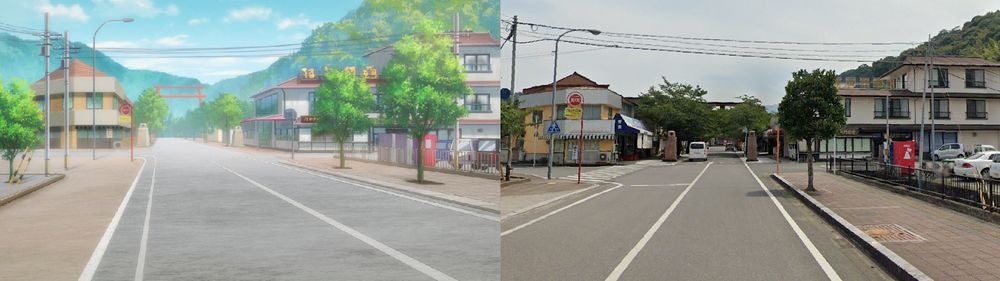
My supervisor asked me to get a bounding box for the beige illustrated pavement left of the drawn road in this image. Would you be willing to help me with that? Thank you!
[0,155,142,280]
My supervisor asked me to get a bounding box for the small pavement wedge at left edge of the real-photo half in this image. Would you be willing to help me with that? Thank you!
[500,177,597,218]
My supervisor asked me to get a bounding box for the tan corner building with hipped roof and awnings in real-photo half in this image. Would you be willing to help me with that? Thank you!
[516,72,653,164]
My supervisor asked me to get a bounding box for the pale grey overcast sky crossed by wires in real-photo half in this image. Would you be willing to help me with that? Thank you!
[500,0,1000,105]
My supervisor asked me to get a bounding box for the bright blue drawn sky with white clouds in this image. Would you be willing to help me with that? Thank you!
[0,0,361,83]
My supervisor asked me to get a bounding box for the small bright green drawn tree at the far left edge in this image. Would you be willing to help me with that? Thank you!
[0,80,44,180]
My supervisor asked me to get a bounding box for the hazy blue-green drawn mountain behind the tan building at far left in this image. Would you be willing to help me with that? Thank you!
[0,33,201,113]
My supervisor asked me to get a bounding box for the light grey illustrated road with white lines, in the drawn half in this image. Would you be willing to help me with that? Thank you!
[83,139,500,280]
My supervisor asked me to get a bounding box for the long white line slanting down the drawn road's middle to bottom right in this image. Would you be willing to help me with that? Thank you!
[222,167,457,281]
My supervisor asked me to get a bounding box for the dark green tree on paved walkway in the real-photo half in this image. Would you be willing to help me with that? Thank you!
[778,69,847,191]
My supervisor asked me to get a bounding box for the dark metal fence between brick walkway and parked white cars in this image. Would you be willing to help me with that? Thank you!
[827,159,1000,212]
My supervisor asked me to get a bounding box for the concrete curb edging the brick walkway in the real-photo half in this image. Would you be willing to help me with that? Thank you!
[771,174,934,280]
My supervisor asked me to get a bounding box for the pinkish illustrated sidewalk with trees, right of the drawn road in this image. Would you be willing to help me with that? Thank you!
[283,155,500,213]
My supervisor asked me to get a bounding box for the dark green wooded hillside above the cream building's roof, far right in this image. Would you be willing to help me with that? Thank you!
[840,10,1000,77]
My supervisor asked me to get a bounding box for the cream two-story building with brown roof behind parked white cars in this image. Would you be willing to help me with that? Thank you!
[800,57,1000,158]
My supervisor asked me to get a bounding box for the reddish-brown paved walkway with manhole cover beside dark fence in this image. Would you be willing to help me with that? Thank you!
[782,171,1000,280]
